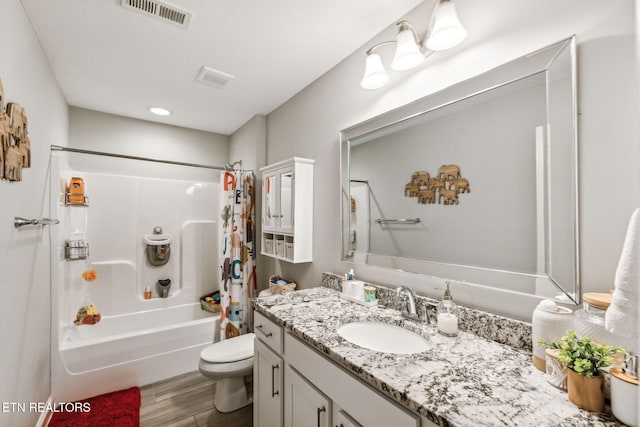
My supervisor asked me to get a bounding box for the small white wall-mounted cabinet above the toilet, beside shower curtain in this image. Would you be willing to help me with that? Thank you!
[260,157,315,263]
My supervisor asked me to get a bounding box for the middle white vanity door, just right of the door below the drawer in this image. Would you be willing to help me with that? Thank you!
[284,365,331,427]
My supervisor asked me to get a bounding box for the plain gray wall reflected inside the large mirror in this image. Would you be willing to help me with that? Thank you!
[350,81,545,274]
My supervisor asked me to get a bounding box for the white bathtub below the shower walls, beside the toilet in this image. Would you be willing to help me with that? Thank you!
[52,303,219,402]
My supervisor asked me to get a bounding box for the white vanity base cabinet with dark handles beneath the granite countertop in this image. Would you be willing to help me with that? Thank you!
[253,311,436,427]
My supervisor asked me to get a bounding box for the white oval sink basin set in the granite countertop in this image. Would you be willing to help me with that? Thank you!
[338,322,431,354]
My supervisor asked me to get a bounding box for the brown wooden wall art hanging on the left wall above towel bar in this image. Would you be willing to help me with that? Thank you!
[0,81,31,181]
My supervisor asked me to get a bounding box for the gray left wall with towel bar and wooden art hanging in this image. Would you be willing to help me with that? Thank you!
[0,0,68,427]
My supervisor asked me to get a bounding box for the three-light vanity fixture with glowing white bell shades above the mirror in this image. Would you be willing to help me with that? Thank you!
[360,0,467,89]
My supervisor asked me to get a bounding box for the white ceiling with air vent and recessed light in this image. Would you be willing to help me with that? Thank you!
[21,0,421,135]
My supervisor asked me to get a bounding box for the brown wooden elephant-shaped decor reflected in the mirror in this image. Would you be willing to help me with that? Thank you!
[404,165,471,205]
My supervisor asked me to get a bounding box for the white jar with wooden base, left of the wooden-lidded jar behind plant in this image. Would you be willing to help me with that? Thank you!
[531,300,573,372]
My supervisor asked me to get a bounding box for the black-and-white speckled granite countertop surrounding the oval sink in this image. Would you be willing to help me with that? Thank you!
[252,287,621,427]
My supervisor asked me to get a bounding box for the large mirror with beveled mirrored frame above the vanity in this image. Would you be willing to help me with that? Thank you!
[340,37,580,303]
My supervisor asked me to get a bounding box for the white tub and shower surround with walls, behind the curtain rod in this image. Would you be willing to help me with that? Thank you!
[51,153,219,402]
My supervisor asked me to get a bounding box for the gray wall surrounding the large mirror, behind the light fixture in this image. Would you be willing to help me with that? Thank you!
[267,0,640,320]
